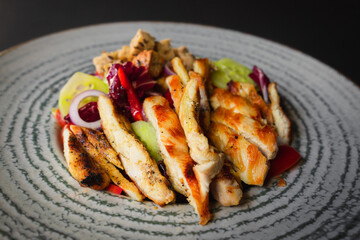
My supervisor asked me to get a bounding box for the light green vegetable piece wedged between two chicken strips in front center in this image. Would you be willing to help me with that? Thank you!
[131,121,163,163]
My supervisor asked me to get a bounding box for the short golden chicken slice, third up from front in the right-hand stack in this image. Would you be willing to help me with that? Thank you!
[210,88,261,120]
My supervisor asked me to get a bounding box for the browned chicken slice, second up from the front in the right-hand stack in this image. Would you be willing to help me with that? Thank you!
[211,107,278,159]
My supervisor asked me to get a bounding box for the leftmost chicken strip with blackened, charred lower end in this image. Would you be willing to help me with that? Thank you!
[62,126,110,190]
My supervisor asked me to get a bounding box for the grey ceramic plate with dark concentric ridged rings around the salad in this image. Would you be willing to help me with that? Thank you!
[0,22,360,239]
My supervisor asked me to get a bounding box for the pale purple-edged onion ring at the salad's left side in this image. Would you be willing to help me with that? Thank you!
[69,90,105,129]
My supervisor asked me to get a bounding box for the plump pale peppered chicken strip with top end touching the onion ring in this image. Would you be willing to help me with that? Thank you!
[98,96,175,206]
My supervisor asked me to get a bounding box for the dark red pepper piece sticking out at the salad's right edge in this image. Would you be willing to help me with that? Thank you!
[267,145,301,179]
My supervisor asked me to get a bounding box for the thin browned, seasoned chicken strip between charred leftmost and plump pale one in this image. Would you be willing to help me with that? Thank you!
[70,125,144,201]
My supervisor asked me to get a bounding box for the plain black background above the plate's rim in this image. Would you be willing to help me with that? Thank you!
[0,0,360,84]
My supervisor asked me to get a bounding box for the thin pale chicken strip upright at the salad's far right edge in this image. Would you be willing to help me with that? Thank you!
[268,82,291,144]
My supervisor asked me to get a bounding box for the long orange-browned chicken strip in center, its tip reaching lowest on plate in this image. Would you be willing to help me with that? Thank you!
[143,96,211,225]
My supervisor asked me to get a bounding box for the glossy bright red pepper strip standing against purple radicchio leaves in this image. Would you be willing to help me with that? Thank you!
[118,67,144,121]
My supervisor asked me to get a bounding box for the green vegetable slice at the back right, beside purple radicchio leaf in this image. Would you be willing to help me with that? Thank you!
[211,58,255,89]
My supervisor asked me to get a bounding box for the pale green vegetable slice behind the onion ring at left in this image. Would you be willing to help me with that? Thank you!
[58,72,109,117]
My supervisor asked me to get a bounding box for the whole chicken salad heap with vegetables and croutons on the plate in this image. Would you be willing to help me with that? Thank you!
[52,30,300,225]
